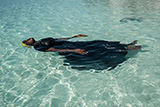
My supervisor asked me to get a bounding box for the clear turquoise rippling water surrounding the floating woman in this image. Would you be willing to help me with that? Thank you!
[0,0,160,107]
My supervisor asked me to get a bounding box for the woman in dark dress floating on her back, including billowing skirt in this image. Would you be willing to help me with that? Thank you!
[22,34,141,69]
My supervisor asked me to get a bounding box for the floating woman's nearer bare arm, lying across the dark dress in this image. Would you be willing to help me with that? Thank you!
[46,48,88,55]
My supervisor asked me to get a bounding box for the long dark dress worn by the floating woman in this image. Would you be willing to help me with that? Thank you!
[34,38,127,70]
